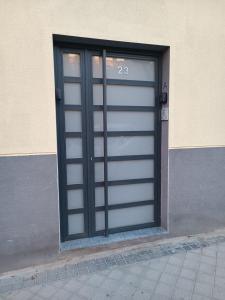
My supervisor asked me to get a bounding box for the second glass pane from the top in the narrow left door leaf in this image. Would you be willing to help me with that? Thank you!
[64,83,81,105]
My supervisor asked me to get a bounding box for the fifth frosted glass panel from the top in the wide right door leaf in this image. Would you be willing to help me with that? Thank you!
[95,159,154,182]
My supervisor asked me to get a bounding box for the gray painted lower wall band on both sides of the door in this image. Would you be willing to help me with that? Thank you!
[0,148,225,272]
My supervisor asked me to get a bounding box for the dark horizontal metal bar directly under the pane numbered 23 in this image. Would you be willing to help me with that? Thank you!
[92,78,156,87]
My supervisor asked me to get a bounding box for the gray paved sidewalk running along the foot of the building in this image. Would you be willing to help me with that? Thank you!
[0,231,225,300]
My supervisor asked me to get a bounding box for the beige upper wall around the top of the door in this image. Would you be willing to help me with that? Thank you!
[0,0,225,155]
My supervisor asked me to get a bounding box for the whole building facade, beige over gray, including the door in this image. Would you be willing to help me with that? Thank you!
[0,0,225,271]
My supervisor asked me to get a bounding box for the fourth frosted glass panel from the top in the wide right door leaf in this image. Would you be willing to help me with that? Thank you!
[94,136,154,157]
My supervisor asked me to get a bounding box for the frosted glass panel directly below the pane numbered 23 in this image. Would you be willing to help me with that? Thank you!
[93,84,155,106]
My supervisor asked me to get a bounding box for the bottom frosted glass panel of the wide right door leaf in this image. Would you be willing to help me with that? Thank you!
[96,205,154,231]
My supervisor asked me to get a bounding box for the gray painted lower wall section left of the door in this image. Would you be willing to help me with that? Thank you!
[0,155,59,270]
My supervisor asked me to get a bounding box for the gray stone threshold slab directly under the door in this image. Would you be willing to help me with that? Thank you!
[60,227,168,251]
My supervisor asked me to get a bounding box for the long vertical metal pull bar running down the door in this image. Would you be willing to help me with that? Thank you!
[102,49,109,236]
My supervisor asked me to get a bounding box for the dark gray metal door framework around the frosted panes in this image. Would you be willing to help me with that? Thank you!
[54,39,161,241]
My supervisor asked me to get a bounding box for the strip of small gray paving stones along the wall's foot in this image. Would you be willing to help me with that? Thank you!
[0,229,225,293]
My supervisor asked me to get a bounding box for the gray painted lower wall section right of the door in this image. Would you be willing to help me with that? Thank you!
[169,148,225,235]
